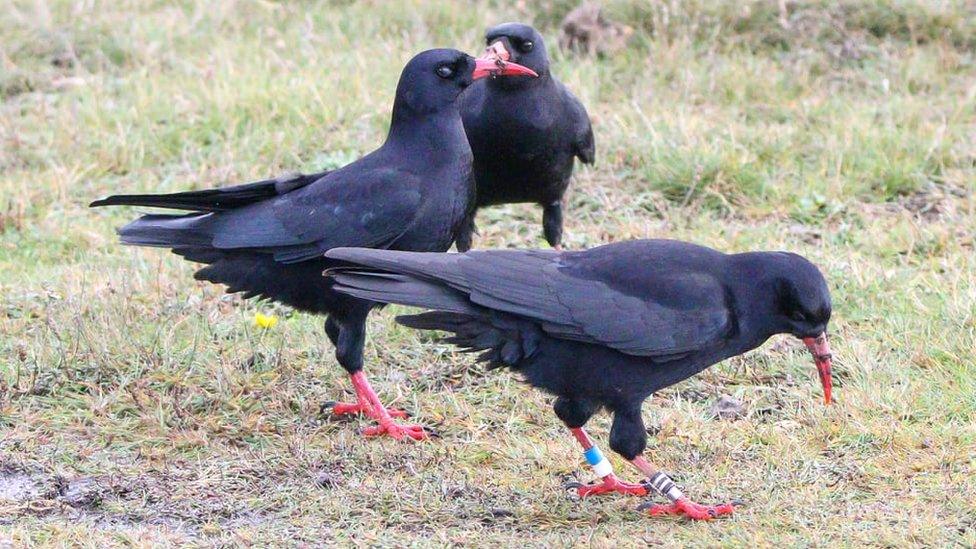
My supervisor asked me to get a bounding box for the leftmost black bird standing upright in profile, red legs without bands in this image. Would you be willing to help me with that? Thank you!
[92,49,534,439]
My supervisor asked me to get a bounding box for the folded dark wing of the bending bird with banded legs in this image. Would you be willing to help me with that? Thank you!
[327,245,732,360]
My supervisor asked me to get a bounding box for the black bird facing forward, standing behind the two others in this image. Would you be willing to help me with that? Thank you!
[458,23,595,251]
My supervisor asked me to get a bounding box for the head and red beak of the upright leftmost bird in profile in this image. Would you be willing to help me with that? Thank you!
[396,49,538,113]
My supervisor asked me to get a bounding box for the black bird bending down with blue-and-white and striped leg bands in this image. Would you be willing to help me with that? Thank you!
[326,240,831,519]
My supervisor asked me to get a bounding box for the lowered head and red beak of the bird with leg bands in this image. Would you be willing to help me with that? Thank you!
[770,252,832,404]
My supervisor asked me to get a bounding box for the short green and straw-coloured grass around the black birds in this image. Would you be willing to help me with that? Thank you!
[0,0,976,547]
